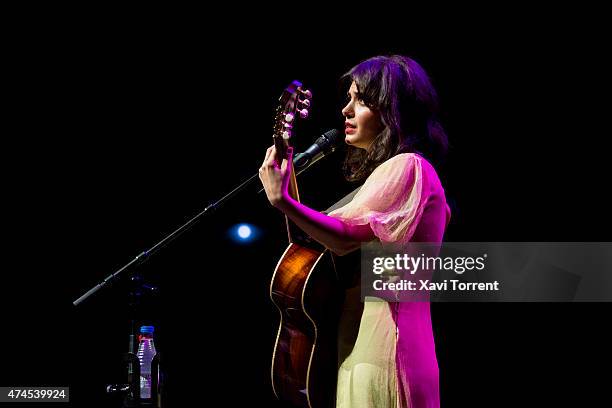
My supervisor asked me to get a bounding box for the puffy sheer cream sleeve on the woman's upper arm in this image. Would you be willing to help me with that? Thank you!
[328,153,426,243]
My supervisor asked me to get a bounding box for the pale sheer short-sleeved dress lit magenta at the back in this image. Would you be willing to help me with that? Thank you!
[328,153,450,408]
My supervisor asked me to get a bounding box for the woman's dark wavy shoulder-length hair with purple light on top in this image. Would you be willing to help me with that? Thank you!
[342,55,448,181]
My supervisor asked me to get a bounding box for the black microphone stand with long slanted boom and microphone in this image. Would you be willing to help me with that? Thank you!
[72,147,336,407]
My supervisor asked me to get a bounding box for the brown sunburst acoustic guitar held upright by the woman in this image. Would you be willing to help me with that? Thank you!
[270,81,343,408]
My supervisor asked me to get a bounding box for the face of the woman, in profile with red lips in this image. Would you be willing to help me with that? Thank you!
[342,82,384,149]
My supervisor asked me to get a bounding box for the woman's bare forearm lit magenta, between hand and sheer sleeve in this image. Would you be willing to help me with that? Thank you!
[276,197,374,255]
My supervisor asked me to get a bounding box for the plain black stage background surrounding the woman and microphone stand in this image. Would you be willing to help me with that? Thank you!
[0,10,612,407]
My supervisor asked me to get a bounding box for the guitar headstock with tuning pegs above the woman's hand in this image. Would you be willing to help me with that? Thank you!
[272,81,312,165]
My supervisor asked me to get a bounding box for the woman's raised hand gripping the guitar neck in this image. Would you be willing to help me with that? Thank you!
[259,146,293,208]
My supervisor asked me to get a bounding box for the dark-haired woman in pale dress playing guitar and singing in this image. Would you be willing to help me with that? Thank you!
[260,55,450,408]
